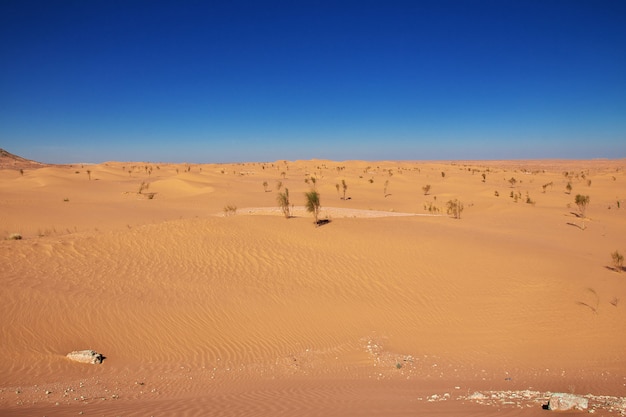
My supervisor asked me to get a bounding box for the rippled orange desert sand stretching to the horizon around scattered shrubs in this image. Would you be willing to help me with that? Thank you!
[0,154,626,416]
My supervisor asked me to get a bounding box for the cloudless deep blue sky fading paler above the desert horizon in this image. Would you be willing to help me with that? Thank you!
[0,0,626,163]
